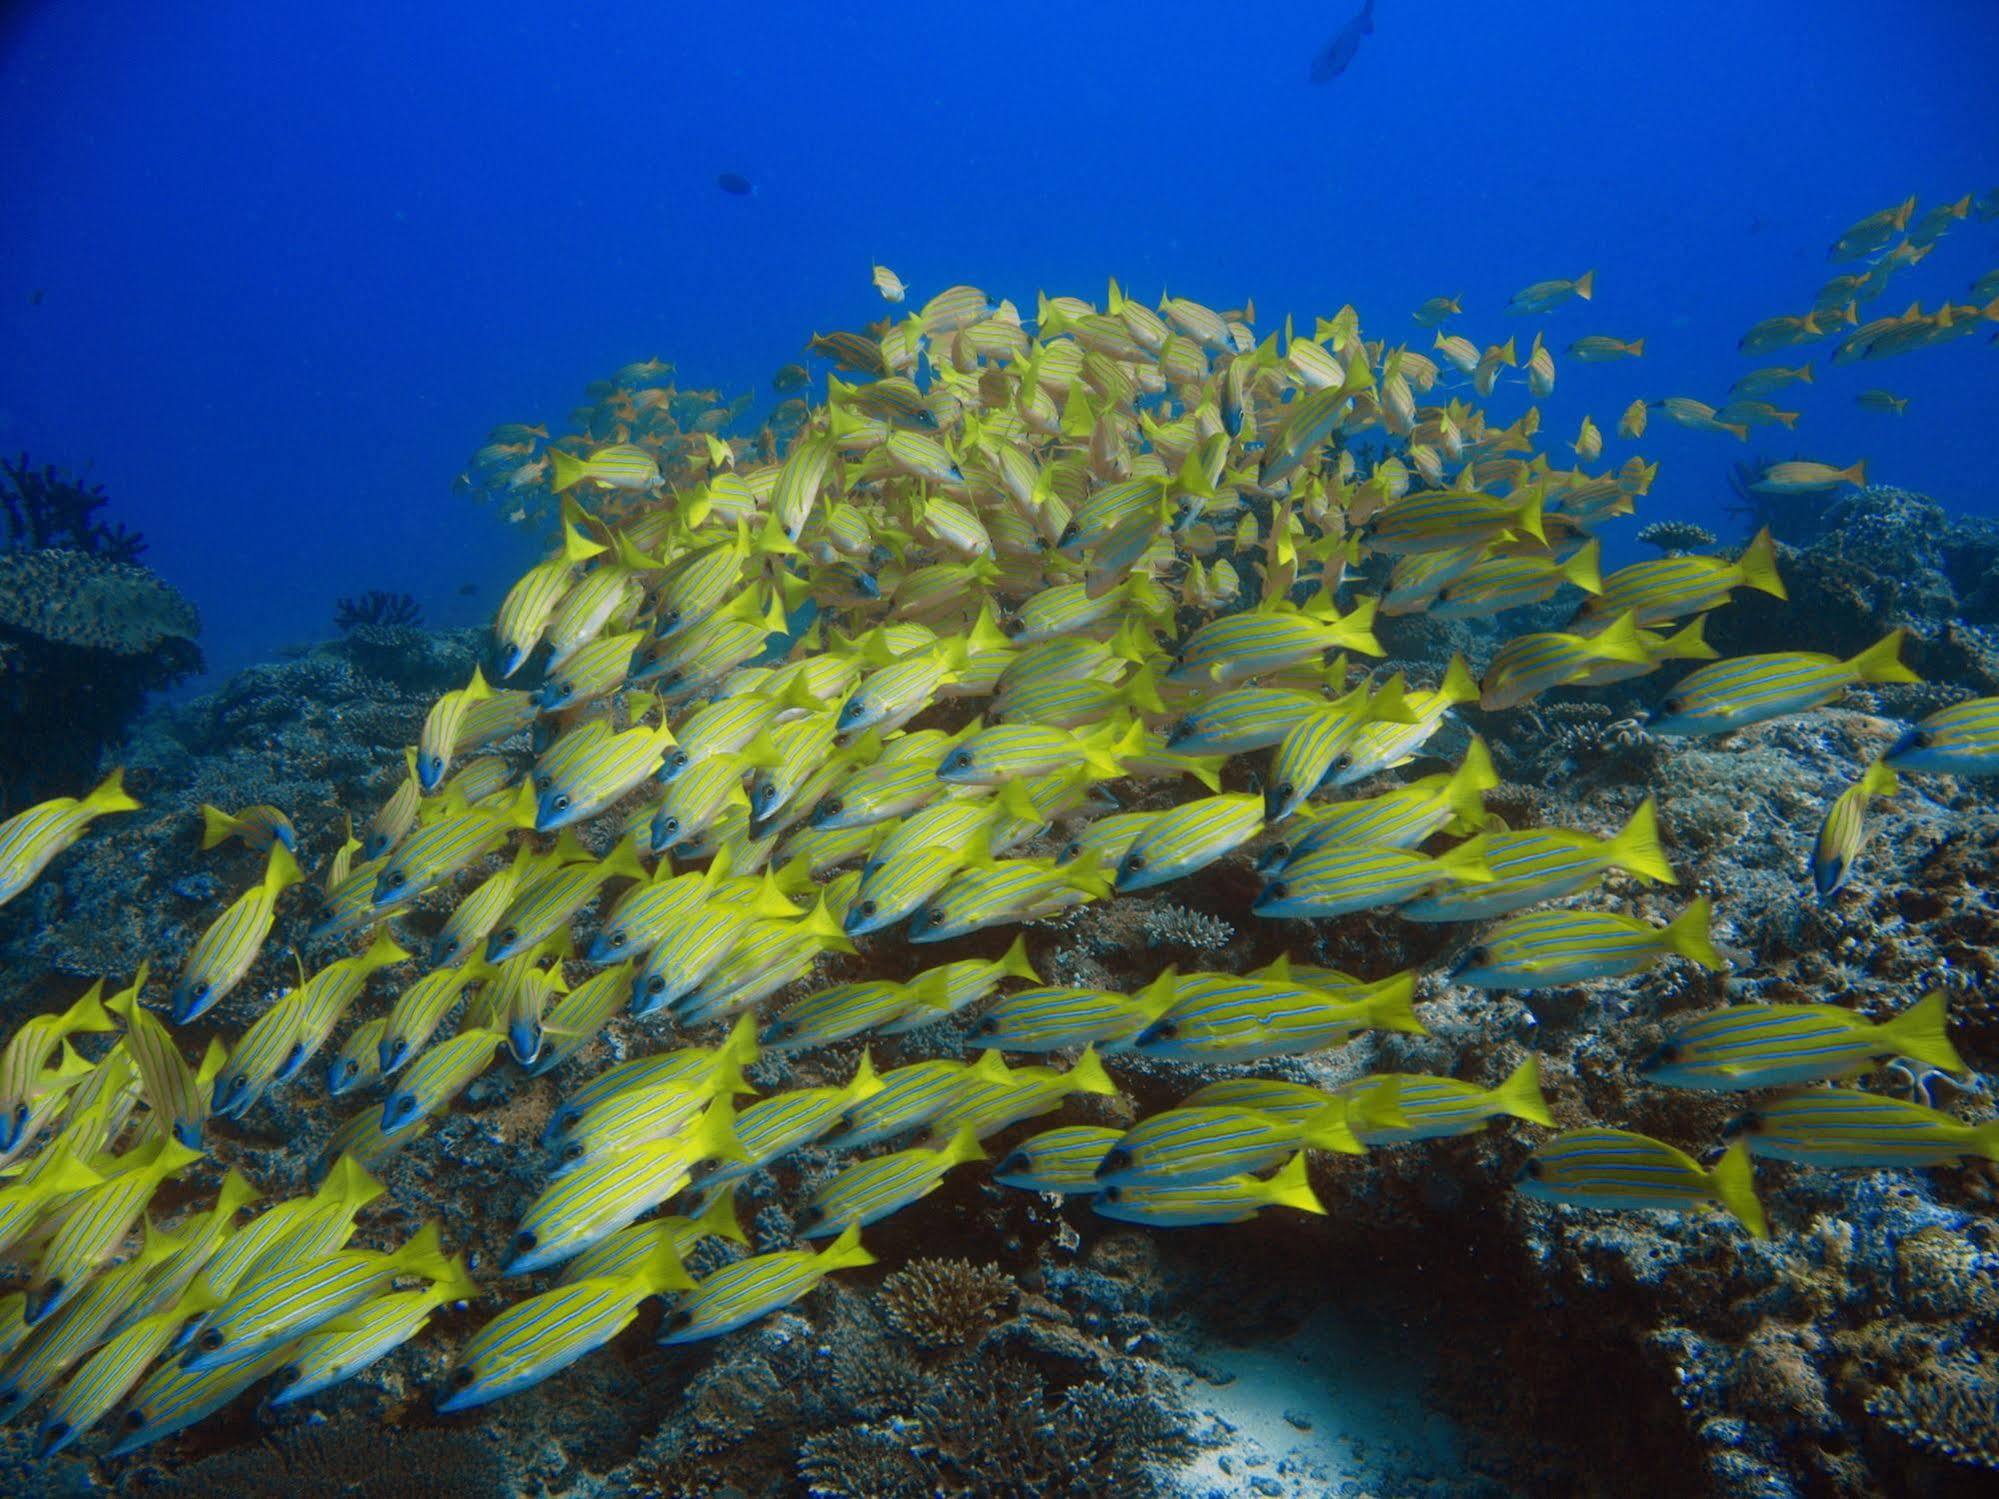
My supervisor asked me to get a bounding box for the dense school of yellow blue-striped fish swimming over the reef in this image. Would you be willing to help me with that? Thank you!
[0,184,1999,1455]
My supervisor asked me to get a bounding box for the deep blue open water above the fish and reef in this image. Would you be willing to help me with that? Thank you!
[0,0,1999,670]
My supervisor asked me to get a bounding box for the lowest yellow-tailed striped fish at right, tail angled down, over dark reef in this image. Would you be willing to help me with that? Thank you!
[1513,1129,1769,1239]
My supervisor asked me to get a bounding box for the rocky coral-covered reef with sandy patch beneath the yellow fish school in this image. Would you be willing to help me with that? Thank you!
[0,490,1999,1499]
